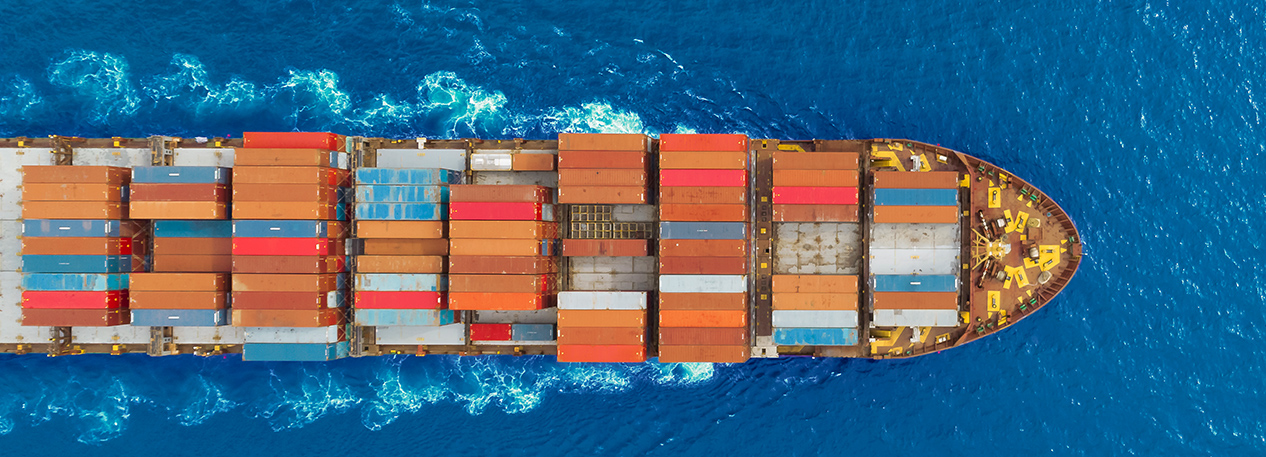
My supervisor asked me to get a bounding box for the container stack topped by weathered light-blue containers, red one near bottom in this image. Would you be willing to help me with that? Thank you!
[353,168,461,327]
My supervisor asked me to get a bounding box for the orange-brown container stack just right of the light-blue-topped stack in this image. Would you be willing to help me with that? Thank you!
[448,185,558,311]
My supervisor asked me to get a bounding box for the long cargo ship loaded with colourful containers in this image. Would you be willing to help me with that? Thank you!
[0,132,1081,363]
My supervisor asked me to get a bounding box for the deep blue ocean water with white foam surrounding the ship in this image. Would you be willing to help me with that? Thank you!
[0,0,1266,456]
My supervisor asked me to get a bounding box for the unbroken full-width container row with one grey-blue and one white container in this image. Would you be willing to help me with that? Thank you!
[658,134,751,363]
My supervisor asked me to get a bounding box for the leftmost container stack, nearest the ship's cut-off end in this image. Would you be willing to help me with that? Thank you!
[22,166,138,327]
